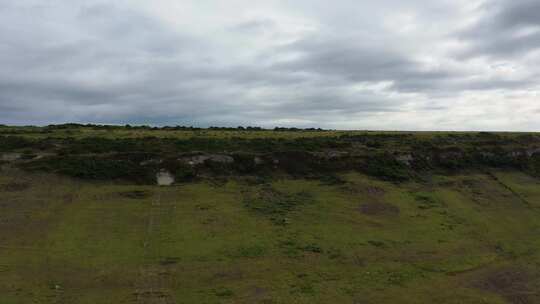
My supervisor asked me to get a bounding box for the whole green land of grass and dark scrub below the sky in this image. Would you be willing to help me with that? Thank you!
[0,125,540,304]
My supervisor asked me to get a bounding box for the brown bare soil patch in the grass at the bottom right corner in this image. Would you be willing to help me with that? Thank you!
[472,267,540,304]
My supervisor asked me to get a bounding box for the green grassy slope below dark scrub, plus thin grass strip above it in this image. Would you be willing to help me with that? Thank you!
[0,128,540,304]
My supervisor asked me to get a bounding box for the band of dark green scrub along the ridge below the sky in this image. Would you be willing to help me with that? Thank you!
[0,125,540,184]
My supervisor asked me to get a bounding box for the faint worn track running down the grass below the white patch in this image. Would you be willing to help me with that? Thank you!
[134,191,176,304]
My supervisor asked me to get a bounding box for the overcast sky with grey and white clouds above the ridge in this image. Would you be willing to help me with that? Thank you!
[0,0,540,131]
